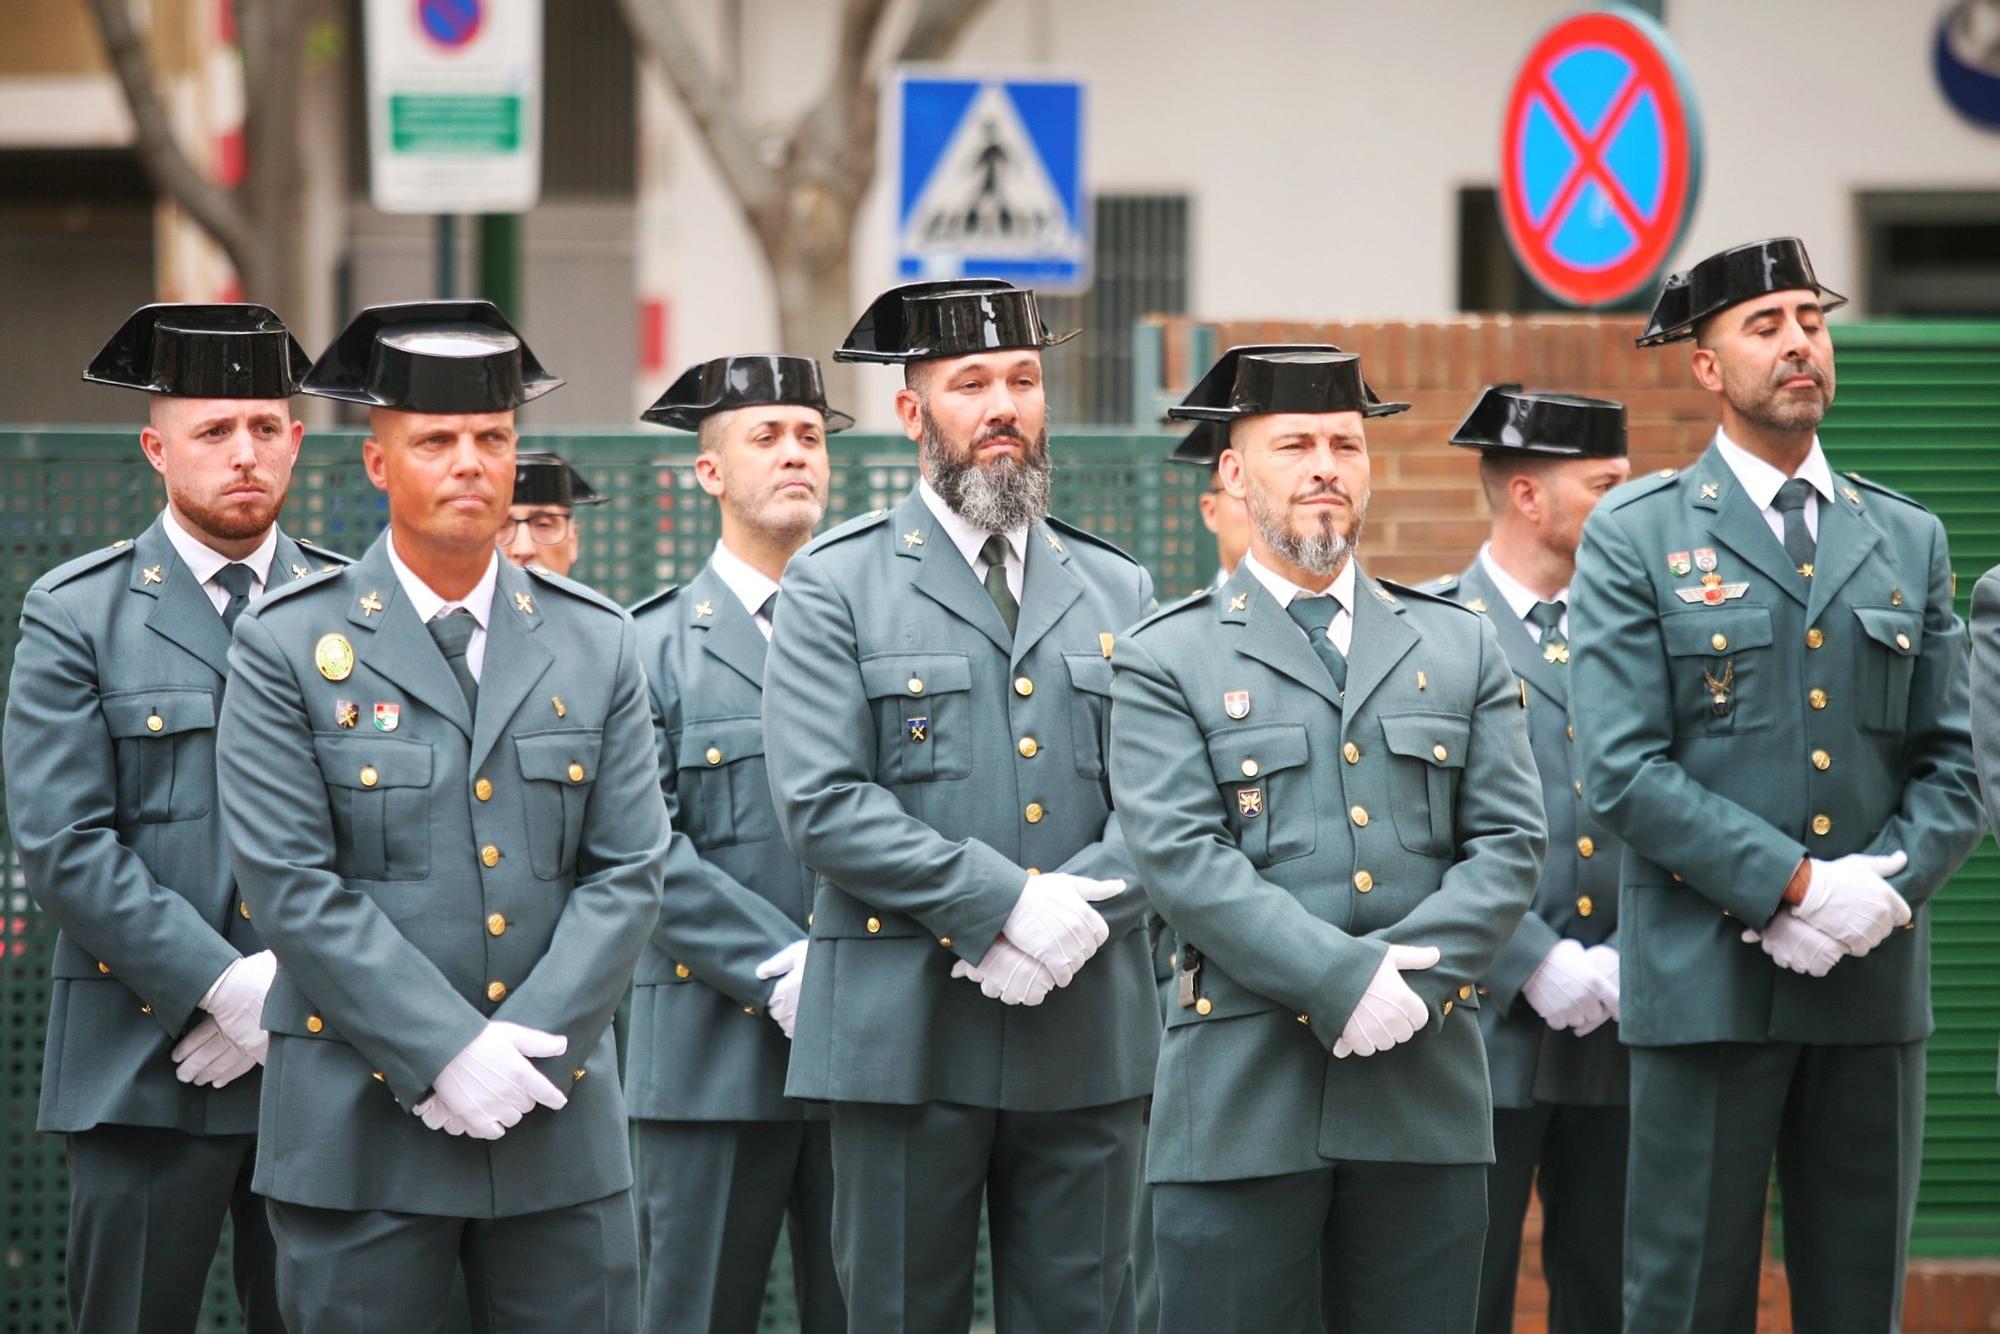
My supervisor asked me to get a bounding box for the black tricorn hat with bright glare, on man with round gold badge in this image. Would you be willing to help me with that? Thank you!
[300,302,562,412]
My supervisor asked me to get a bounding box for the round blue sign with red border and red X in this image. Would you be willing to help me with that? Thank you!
[1500,10,1702,306]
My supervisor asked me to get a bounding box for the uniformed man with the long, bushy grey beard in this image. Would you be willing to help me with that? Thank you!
[764,282,1160,1334]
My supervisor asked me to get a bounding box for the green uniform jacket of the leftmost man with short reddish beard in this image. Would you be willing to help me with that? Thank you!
[4,516,346,1134]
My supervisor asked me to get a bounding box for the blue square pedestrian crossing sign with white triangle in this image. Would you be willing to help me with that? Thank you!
[896,72,1090,290]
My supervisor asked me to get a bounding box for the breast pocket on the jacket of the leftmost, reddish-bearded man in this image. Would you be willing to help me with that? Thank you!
[100,686,216,824]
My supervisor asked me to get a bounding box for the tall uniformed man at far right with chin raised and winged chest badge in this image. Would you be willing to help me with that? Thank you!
[1570,238,1980,1334]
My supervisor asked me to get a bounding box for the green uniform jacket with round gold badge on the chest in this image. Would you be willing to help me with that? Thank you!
[218,538,666,1218]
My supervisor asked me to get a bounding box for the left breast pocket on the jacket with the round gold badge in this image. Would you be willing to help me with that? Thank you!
[312,736,430,880]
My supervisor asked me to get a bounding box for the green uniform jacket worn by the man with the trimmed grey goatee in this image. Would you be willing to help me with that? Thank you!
[1112,568,1544,1182]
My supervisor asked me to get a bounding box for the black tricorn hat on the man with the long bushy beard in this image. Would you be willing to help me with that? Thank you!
[834,278,1082,362]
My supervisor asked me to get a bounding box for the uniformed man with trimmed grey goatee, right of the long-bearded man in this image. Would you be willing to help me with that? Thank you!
[1112,346,1542,1334]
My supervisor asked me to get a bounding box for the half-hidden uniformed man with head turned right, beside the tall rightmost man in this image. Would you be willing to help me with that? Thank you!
[1434,384,1632,1334]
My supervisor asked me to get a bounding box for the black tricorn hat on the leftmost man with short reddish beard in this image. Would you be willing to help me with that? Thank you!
[84,302,312,398]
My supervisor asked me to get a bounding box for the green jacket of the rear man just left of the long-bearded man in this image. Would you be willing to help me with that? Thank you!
[626,566,824,1120]
